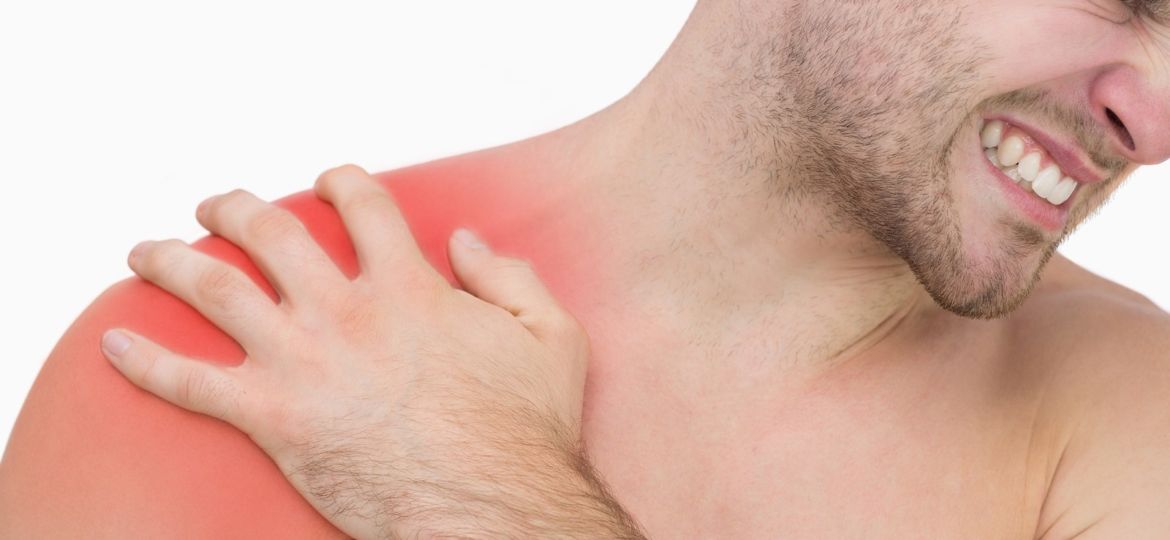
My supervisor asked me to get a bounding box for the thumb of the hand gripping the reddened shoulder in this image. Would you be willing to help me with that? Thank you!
[447,229,585,345]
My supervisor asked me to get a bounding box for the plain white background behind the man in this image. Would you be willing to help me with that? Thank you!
[0,0,1170,451]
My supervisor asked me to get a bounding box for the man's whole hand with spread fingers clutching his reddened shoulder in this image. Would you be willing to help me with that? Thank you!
[103,166,645,538]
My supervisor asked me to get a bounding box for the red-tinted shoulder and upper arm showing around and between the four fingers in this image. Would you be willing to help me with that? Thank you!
[0,184,383,538]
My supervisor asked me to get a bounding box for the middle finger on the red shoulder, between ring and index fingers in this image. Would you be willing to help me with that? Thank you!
[195,189,347,304]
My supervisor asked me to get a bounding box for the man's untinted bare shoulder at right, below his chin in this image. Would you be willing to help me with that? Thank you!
[1016,257,1170,538]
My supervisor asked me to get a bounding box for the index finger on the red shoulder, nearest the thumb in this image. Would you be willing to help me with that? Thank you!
[314,165,429,275]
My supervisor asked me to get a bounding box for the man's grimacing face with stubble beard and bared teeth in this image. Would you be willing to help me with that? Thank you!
[779,0,1170,317]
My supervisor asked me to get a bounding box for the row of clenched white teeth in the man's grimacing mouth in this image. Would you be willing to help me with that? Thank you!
[980,120,1076,206]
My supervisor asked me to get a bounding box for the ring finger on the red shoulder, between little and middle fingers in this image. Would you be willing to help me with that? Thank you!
[129,240,285,351]
